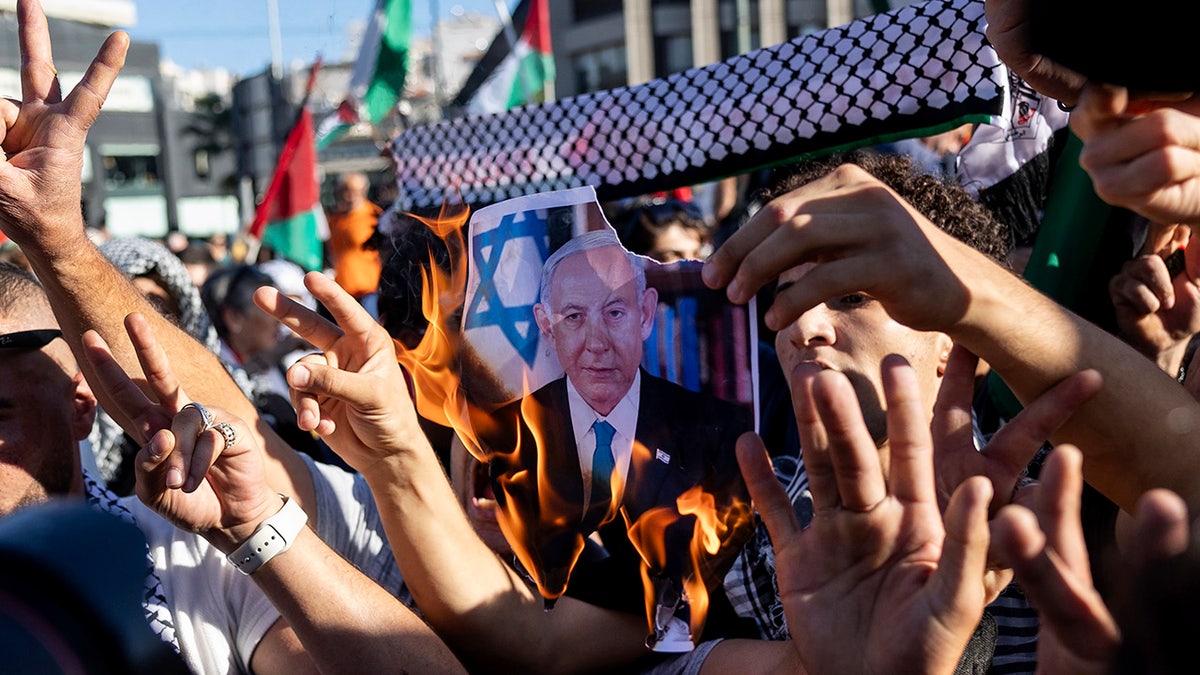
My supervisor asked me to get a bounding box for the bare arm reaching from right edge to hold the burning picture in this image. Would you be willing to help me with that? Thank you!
[704,166,1200,510]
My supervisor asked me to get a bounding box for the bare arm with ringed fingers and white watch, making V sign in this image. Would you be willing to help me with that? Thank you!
[85,319,461,674]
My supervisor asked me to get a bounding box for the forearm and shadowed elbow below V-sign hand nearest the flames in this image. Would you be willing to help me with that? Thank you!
[364,452,647,673]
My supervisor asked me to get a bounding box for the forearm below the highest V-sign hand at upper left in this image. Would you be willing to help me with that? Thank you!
[22,226,314,504]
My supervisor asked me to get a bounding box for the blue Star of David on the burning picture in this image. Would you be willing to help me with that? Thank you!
[466,211,550,366]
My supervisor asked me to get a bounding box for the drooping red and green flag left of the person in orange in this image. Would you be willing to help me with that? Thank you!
[248,106,329,270]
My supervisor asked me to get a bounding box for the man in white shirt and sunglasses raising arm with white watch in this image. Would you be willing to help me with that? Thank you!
[0,258,455,673]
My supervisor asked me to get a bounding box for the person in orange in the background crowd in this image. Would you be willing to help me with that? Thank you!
[328,173,383,306]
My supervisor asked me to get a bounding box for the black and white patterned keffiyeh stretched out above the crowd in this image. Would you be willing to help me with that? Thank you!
[391,0,1009,209]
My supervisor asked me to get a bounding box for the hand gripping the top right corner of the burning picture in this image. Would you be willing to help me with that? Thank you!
[703,165,984,331]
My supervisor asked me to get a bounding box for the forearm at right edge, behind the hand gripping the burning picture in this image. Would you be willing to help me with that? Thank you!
[950,259,1200,512]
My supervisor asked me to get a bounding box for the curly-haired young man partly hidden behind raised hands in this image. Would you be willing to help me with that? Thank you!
[710,153,1087,665]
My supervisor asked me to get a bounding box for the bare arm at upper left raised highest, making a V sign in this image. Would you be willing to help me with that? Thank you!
[0,0,313,504]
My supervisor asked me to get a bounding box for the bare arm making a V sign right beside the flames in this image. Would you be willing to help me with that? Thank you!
[256,274,647,673]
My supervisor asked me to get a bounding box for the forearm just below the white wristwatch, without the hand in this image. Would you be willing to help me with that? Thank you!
[252,527,463,673]
